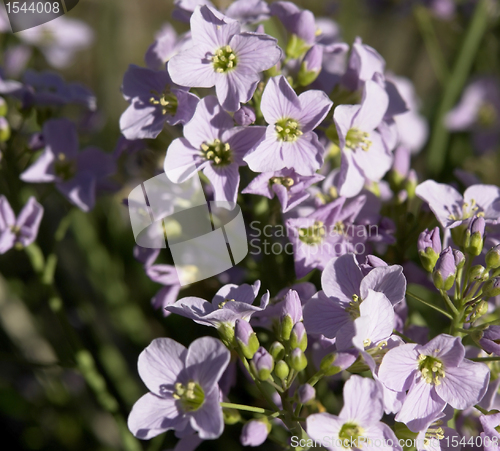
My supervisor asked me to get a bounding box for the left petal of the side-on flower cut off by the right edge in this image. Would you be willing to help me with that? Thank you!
[415,180,464,228]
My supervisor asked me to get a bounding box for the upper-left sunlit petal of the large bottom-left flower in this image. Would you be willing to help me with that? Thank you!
[137,338,187,396]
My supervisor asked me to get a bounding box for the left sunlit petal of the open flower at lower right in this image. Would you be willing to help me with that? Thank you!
[378,344,419,391]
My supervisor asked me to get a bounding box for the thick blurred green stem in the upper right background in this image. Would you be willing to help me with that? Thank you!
[427,0,489,176]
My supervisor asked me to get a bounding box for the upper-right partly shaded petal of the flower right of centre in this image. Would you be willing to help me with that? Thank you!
[360,265,406,305]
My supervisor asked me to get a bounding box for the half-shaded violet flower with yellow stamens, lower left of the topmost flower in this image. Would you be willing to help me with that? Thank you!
[120,64,199,140]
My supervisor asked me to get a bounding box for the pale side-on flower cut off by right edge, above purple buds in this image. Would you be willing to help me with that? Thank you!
[415,180,500,229]
